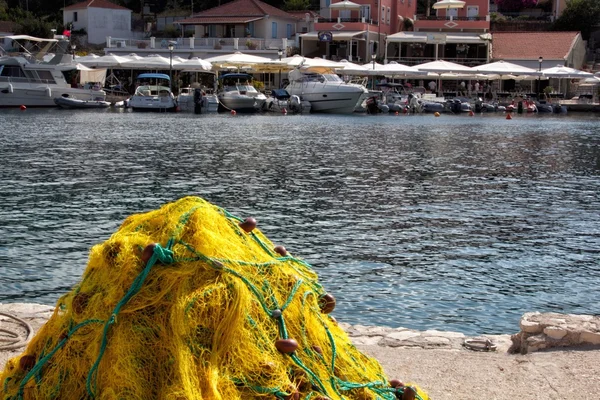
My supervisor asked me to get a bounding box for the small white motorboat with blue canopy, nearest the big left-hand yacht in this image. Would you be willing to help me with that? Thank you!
[128,73,178,112]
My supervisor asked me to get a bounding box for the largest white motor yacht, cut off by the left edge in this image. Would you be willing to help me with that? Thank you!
[0,35,106,107]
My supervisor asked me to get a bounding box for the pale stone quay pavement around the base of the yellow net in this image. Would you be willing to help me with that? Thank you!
[0,303,600,400]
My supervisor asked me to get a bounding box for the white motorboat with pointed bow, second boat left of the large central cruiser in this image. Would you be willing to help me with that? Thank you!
[217,73,267,112]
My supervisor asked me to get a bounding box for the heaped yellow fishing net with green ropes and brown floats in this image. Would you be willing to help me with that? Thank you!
[0,197,426,400]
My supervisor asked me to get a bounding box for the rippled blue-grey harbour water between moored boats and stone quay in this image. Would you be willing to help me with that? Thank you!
[0,110,600,334]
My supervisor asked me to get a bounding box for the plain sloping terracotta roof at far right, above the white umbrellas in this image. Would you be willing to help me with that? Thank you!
[492,32,581,60]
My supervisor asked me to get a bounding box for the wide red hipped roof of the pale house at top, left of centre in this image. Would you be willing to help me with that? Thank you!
[178,0,299,24]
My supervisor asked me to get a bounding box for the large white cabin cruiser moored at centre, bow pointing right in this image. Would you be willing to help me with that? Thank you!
[285,68,369,114]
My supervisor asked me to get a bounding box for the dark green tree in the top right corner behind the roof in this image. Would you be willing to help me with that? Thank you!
[553,0,600,40]
